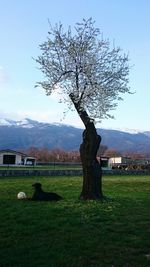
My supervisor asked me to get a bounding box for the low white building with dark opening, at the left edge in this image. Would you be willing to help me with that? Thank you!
[0,149,36,165]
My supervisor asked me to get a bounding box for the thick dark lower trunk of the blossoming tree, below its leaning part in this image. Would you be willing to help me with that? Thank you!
[80,122,103,200]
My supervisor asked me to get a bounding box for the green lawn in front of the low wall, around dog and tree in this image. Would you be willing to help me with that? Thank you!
[0,176,150,267]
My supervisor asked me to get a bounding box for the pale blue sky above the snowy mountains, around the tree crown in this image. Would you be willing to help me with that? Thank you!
[0,0,150,131]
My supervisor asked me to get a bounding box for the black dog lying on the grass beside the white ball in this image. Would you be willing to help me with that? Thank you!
[31,183,62,201]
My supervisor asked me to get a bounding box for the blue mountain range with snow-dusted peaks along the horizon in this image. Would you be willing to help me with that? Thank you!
[0,118,150,153]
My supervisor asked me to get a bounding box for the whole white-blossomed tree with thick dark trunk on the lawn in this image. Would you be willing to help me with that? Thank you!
[36,18,130,200]
